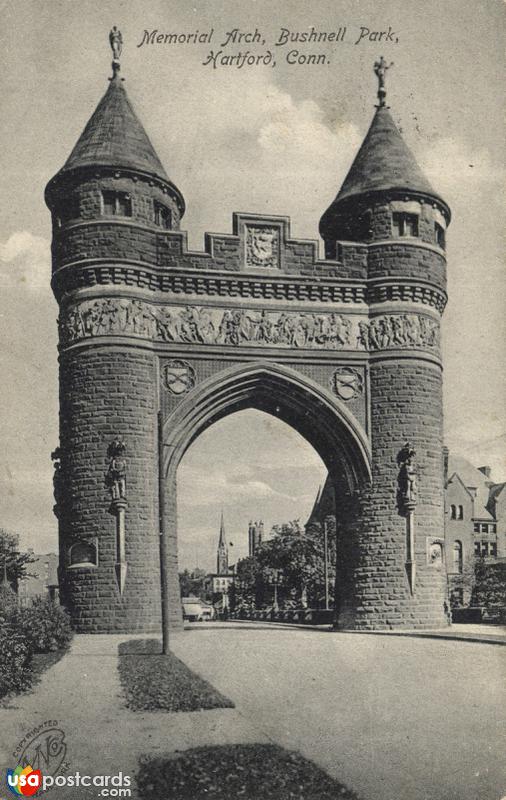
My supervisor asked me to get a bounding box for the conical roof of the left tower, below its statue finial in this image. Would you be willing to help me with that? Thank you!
[61,72,169,182]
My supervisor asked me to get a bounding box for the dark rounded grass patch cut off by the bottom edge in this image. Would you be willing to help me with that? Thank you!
[137,744,358,800]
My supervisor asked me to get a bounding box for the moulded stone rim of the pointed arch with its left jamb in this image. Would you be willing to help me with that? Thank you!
[161,363,370,627]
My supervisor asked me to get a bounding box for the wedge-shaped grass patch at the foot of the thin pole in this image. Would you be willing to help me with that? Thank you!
[118,639,234,711]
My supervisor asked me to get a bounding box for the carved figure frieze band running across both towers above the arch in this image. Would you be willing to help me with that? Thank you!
[59,298,439,352]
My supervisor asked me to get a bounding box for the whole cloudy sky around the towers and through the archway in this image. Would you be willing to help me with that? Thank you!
[0,0,506,569]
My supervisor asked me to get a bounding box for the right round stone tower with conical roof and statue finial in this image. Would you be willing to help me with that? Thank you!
[320,58,450,628]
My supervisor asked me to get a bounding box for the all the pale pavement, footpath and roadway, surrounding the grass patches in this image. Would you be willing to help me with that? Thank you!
[0,623,506,800]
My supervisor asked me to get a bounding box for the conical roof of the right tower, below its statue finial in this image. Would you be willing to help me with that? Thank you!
[334,106,438,205]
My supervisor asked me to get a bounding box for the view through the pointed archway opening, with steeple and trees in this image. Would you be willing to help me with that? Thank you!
[177,409,328,619]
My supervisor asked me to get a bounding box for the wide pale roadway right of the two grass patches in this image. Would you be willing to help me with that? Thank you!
[173,623,506,800]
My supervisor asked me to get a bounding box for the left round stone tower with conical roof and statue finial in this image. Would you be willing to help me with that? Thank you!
[46,37,185,631]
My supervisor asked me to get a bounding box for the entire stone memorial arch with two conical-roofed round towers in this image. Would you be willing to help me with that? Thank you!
[46,36,450,632]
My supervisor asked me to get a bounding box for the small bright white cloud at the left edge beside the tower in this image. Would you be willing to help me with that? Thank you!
[0,230,51,292]
